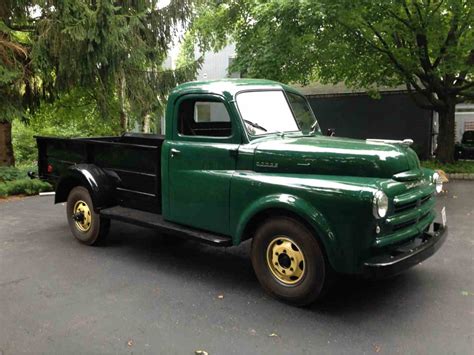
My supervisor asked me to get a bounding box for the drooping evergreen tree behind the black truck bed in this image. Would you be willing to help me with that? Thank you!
[35,0,196,131]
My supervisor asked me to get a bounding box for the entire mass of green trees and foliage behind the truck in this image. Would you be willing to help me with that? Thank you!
[0,0,474,200]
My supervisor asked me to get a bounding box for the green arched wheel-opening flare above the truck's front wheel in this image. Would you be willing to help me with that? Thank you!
[233,194,342,266]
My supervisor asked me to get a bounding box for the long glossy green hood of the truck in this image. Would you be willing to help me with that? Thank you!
[254,135,420,178]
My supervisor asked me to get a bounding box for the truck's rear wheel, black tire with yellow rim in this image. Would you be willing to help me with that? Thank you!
[66,186,110,245]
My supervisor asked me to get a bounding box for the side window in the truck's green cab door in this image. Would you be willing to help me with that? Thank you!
[178,99,232,137]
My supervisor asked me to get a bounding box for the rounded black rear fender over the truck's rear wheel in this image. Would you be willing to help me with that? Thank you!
[54,164,118,210]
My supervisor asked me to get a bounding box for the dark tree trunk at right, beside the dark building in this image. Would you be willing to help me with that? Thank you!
[436,101,456,163]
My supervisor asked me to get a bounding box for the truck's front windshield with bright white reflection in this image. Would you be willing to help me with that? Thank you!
[237,90,316,135]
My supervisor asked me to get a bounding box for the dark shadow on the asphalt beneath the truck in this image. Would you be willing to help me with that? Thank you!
[101,223,435,317]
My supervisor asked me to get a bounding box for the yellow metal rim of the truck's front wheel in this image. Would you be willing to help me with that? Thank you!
[267,236,306,285]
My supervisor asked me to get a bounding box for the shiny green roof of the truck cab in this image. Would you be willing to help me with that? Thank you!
[169,79,298,101]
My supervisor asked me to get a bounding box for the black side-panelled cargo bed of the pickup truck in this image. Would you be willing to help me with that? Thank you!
[35,133,165,213]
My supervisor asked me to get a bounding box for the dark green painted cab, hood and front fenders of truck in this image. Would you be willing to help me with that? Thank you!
[162,79,435,273]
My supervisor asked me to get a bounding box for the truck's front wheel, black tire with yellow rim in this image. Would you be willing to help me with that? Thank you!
[251,217,332,306]
